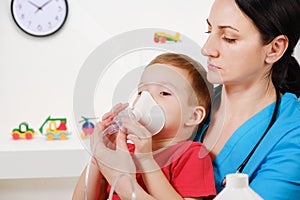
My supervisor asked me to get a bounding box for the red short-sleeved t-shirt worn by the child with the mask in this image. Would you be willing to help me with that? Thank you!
[107,141,216,200]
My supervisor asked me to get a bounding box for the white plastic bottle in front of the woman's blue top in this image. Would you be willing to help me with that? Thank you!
[214,173,263,200]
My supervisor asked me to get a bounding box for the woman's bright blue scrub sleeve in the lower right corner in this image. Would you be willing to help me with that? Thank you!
[250,127,300,200]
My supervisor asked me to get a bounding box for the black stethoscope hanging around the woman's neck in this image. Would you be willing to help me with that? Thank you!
[217,89,281,186]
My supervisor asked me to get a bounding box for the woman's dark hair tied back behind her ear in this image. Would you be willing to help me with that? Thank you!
[235,0,300,97]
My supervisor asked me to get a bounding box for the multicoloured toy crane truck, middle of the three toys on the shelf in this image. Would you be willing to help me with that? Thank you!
[39,116,71,140]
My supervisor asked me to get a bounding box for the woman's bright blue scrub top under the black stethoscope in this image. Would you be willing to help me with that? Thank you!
[197,93,300,200]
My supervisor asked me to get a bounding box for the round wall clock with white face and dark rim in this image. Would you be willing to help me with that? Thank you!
[11,0,68,37]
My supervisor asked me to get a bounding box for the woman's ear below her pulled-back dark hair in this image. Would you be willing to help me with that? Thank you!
[265,35,289,64]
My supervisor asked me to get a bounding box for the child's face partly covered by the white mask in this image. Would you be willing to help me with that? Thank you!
[138,64,197,138]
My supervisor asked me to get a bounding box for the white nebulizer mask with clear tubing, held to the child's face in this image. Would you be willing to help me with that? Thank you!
[84,91,165,200]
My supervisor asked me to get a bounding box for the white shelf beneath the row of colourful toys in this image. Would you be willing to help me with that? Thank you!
[0,134,89,180]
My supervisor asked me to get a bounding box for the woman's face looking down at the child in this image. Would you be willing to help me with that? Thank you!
[202,0,270,86]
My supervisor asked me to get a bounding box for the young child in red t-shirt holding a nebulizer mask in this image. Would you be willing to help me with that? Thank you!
[74,53,215,199]
